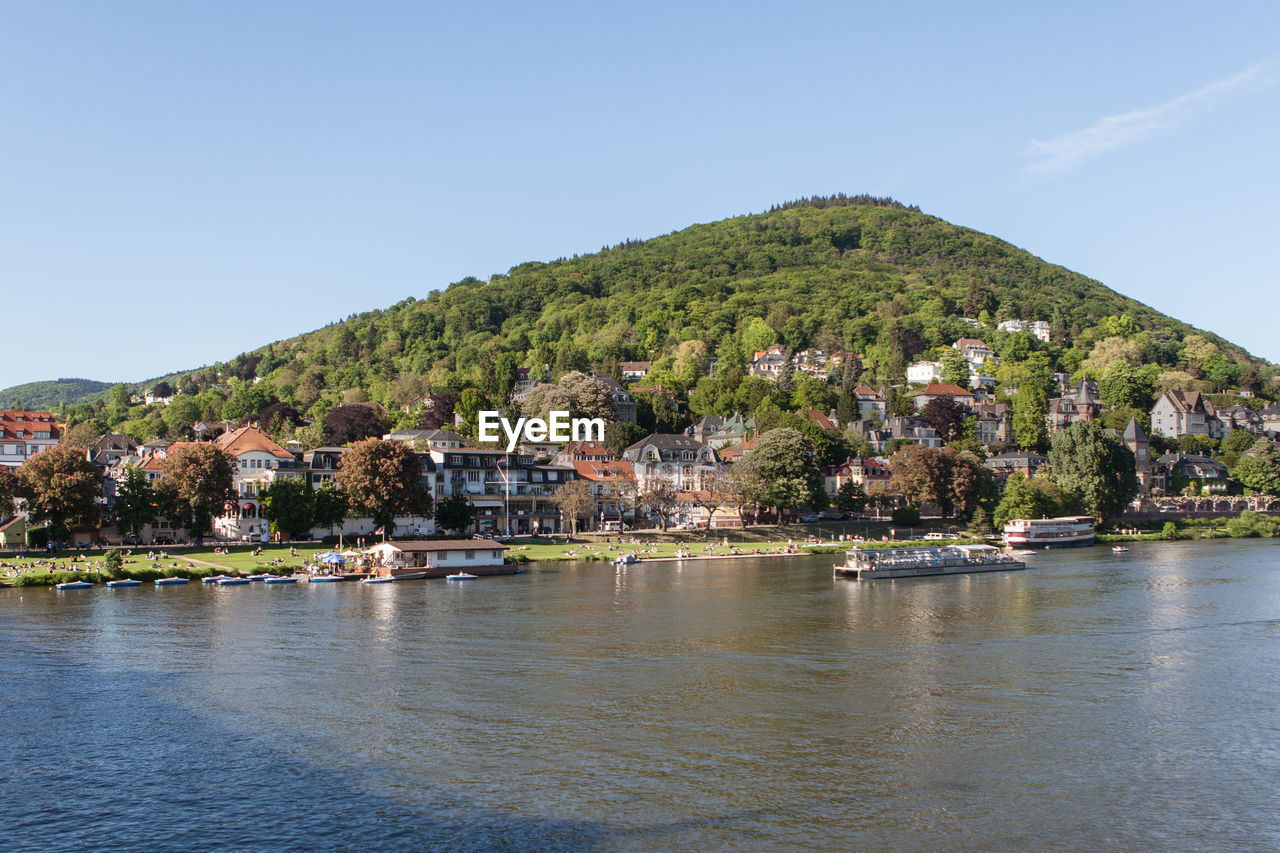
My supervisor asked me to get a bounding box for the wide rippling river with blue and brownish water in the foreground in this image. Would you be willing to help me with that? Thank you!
[0,540,1280,853]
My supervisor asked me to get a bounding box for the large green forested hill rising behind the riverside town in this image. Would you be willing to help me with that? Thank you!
[20,196,1274,438]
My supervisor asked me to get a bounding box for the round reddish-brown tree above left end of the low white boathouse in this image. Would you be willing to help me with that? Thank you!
[338,438,431,538]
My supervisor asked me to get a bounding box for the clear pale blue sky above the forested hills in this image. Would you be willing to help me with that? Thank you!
[0,0,1280,387]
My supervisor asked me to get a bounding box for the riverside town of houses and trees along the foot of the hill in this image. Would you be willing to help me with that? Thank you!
[0,308,1280,548]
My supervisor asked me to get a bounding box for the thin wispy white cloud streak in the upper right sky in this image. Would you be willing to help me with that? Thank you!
[1023,63,1272,174]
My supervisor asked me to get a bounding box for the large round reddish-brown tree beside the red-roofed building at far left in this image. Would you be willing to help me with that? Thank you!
[18,444,102,538]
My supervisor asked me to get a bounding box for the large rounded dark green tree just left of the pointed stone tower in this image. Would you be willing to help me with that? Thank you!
[1048,420,1138,521]
